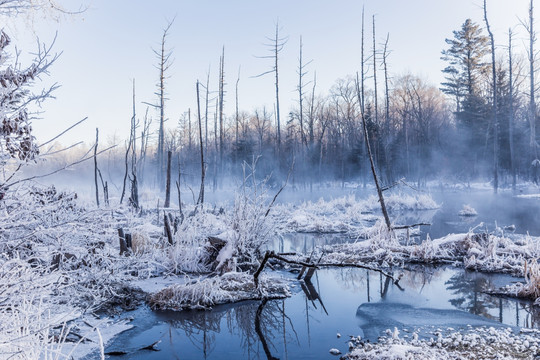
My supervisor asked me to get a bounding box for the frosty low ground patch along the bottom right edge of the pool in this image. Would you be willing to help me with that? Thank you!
[342,327,540,360]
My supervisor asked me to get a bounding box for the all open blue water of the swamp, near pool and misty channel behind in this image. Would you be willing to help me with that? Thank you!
[102,191,540,359]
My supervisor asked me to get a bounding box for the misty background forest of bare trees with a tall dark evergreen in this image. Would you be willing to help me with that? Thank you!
[4,1,540,202]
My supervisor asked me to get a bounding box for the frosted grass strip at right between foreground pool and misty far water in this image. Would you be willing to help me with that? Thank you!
[321,226,540,276]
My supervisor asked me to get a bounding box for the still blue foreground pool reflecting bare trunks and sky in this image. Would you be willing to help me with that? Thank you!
[106,268,539,359]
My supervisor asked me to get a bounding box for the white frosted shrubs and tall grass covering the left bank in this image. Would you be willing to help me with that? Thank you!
[0,176,288,359]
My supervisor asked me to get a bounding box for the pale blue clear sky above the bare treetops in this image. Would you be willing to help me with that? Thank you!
[0,0,540,145]
